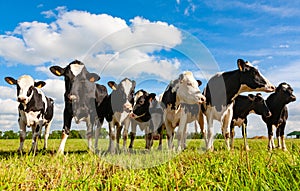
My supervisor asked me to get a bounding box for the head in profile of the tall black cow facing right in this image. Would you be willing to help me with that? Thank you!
[237,59,275,92]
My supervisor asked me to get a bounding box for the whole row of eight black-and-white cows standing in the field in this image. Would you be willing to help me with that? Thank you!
[5,59,296,154]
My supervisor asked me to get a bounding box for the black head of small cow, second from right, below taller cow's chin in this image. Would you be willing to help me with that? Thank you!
[248,93,272,117]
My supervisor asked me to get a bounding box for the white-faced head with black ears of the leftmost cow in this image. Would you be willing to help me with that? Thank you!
[5,75,46,104]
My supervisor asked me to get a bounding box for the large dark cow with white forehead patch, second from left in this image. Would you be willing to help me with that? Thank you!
[50,60,107,154]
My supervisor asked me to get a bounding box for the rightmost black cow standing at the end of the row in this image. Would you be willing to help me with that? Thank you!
[262,82,296,150]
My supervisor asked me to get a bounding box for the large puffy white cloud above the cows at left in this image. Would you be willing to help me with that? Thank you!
[0,7,182,81]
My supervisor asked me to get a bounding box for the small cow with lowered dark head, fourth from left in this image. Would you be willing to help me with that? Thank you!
[129,89,162,149]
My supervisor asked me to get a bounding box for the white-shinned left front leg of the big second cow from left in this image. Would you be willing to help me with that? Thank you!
[57,110,72,154]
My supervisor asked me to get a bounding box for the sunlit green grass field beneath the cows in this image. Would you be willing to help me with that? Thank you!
[0,139,300,190]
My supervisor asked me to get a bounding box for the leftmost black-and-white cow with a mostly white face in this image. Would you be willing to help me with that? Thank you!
[5,75,54,152]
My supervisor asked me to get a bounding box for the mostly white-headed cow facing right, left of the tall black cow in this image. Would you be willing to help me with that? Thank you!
[162,71,205,151]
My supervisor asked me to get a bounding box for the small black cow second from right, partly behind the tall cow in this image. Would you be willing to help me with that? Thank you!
[230,93,272,150]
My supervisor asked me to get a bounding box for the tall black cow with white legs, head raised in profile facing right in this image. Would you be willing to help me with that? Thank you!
[202,59,275,150]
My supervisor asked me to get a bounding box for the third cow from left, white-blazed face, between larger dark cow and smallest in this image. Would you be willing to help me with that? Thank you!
[97,78,136,154]
